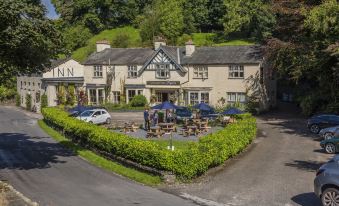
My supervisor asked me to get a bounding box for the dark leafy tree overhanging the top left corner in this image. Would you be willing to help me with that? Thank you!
[0,0,61,75]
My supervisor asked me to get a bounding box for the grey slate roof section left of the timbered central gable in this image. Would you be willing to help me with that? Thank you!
[83,48,154,65]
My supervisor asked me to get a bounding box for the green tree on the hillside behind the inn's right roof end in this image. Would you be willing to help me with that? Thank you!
[223,0,276,40]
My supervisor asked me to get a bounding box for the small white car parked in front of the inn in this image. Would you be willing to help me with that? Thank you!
[76,109,112,124]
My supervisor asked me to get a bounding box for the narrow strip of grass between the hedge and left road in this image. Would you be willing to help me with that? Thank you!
[38,120,161,186]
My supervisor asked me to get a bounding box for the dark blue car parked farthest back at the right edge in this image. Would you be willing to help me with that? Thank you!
[307,114,339,134]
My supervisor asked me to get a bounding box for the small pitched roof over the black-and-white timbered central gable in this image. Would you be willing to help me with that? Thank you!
[139,45,187,75]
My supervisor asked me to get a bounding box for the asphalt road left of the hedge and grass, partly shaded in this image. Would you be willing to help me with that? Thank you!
[0,106,194,206]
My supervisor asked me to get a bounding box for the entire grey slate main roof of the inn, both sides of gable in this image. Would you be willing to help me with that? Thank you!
[84,45,263,65]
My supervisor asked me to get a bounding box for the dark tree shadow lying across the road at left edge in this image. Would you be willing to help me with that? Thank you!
[0,133,75,170]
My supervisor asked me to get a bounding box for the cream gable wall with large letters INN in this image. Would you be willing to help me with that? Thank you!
[42,59,84,78]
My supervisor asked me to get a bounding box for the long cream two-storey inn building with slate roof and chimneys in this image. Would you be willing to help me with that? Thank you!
[17,38,276,110]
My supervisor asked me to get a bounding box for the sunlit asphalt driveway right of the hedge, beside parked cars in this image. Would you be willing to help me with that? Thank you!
[170,114,332,206]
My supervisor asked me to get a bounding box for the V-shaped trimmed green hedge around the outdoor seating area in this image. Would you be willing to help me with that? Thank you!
[42,108,256,180]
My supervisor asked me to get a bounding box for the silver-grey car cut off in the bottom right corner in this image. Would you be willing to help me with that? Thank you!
[314,155,339,206]
